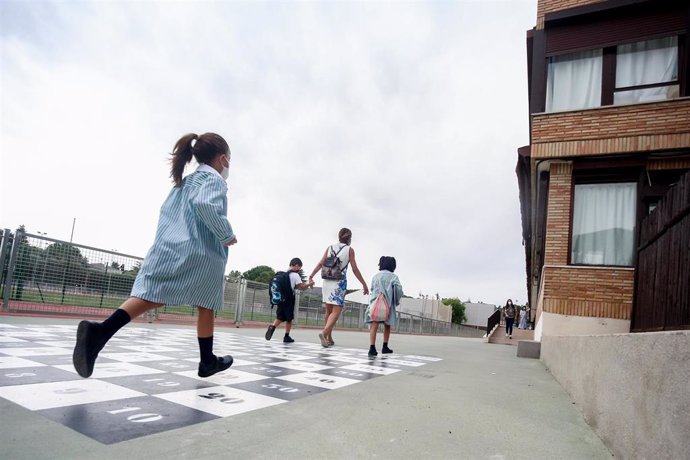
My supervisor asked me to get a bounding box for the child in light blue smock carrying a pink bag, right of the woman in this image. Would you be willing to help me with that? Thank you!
[365,256,403,357]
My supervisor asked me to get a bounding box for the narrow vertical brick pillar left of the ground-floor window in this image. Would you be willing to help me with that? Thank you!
[544,163,573,265]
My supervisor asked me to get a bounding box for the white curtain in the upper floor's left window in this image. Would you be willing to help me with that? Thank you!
[546,49,602,112]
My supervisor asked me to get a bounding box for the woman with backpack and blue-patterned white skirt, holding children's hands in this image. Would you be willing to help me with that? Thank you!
[309,228,369,348]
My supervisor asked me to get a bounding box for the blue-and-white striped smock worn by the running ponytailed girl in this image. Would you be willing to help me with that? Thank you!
[131,164,235,310]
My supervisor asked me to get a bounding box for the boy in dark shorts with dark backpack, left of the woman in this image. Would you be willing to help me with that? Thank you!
[265,257,314,343]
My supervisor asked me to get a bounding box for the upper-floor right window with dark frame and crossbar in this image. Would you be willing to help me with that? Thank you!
[613,37,679,104]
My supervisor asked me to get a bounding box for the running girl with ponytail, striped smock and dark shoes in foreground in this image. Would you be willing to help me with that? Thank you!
[72,133,237,378]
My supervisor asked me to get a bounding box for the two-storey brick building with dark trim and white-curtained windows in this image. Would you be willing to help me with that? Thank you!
[516,0,690,340]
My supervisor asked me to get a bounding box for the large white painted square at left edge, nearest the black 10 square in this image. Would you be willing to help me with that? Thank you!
[0,379,146,410]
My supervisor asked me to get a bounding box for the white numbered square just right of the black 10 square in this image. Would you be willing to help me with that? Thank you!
[154,386,287,417]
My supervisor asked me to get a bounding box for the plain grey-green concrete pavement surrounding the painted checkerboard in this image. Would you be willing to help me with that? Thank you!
[0,316,611,460]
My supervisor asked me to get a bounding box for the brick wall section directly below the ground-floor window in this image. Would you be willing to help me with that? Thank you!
[542,266,635,320]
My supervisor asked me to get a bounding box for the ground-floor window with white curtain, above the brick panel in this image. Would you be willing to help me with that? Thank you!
[570,183,637,266]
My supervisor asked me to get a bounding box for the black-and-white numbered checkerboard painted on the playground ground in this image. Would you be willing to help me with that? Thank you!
[0,324,440,444]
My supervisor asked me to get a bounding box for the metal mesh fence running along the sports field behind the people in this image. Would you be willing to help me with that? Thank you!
[0,228,484,337]
